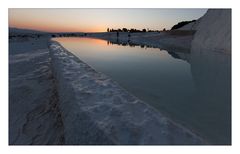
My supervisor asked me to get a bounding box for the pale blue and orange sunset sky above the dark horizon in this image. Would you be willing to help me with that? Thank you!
[9,8,207,32]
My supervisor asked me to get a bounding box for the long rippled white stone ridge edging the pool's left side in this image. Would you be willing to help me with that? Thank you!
[49,41,204,145]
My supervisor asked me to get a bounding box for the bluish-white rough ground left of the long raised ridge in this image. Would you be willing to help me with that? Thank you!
[9,38,64,145]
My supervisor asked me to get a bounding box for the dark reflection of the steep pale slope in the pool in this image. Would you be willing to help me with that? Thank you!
[190,50,231,144]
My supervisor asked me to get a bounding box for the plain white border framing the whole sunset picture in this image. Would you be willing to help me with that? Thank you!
[0,0,240,154]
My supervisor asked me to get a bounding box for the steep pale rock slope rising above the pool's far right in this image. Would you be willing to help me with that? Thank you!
[191,9,231,54]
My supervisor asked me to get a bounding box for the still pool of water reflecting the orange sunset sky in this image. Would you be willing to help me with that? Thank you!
[54,38,231,144]
